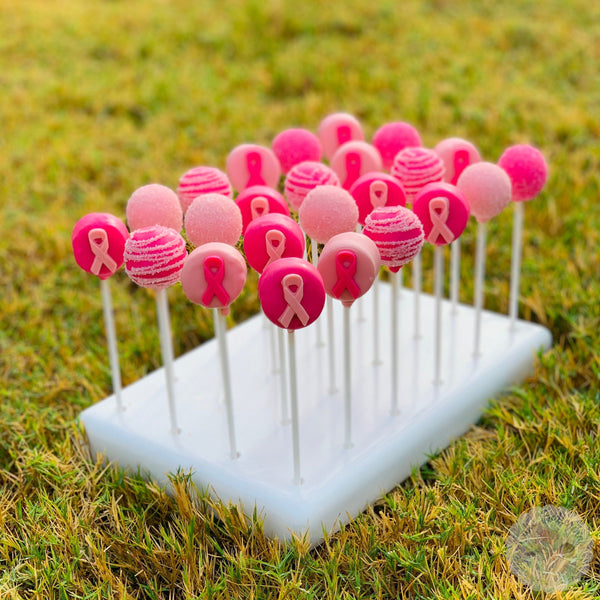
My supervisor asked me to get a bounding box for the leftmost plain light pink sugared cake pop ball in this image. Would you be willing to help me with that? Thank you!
[125,183,183,231]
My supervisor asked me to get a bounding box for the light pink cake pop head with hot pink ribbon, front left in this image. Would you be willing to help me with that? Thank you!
[181,242,247,315]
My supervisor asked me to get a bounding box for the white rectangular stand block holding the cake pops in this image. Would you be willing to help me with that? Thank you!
[80,282,552,544]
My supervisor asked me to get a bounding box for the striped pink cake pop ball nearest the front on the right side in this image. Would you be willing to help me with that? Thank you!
[363,206,425,272]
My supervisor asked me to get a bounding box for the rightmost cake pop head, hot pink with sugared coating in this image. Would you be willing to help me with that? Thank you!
[498,144,548,202]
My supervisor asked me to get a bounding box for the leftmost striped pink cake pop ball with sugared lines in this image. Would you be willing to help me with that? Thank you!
[124,225,187,290]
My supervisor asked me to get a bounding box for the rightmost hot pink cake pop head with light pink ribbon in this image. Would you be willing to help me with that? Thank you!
[413,182,470,246]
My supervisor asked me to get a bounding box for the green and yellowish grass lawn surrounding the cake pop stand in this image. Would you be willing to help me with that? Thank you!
[0,0,600,600]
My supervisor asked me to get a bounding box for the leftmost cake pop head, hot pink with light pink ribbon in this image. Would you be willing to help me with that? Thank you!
[71,213,129,280]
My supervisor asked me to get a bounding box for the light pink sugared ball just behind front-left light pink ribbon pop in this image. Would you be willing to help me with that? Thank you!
[185,194,242,246]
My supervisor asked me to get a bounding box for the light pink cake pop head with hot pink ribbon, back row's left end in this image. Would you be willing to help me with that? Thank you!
[225,144,281,192]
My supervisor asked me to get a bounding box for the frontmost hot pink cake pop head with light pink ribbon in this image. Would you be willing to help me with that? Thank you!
[258,258,325,329]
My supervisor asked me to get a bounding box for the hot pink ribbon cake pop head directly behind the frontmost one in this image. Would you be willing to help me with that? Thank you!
[244,213,305,273]
